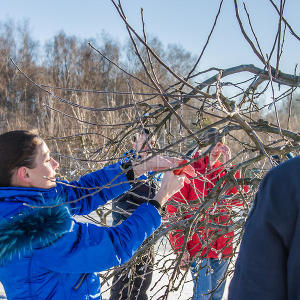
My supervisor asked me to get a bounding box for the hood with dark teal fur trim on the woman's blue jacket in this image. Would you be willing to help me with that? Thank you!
[0,186,72,265]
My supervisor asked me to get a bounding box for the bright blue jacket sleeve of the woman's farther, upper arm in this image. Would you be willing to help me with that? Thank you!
[57,162,131,215]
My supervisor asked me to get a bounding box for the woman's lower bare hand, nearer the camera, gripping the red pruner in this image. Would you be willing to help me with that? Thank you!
[154,171,185,206]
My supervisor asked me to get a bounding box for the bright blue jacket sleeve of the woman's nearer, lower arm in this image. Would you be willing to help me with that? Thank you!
[33,203,161,273]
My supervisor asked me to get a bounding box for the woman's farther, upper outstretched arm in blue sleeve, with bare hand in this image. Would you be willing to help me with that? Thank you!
[56,156,180,215]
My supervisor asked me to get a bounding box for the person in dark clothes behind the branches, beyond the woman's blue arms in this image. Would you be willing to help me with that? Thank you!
[110,129,159,300]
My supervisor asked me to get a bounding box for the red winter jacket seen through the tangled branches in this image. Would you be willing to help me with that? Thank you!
[167,153,249,258]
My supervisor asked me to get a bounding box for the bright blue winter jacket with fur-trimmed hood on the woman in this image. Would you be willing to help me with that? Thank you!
[0,163,161,300]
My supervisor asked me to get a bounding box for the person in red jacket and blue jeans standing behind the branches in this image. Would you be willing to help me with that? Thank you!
[167,128,248,300]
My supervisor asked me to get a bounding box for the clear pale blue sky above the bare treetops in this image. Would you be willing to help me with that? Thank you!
[0,0,300,73]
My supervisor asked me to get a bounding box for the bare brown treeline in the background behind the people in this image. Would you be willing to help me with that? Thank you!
[0,21,300,176]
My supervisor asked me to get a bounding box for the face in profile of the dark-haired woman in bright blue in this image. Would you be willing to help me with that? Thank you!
[27,142,59,189]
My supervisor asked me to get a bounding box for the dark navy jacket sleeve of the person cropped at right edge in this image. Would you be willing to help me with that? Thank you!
[228,159,300,300]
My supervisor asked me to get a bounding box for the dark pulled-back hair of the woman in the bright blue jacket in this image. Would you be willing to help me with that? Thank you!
[0,130,43,186]
